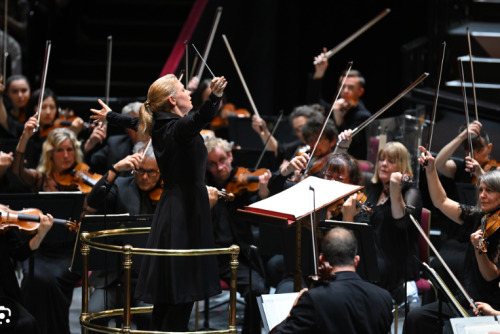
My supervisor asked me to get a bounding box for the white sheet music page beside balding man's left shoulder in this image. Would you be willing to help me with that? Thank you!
[261,292,299,330]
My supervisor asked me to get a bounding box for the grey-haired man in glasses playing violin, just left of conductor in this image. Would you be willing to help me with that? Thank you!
[87,142,161,329]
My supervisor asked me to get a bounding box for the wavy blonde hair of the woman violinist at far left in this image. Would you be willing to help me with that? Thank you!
[37,128,83,175]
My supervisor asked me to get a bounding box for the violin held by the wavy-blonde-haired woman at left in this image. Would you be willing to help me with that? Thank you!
[55,162,102,194]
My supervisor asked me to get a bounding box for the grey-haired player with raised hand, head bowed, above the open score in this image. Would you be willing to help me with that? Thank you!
[252,105,323,163]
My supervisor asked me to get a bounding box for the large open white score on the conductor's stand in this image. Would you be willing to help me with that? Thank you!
[248,176,363,218]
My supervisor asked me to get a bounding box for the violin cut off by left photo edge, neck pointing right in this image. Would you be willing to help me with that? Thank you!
[0,204,78,234]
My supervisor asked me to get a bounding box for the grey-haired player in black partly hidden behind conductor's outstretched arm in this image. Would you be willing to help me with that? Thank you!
[84,102,142,174]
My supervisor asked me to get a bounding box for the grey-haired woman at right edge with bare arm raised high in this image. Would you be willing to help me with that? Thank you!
[404,147,500,334]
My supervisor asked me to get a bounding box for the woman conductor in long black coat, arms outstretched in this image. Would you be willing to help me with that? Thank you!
[91,74,227,331]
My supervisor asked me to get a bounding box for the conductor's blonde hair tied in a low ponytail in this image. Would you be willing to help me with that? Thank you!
[138,74,178,138]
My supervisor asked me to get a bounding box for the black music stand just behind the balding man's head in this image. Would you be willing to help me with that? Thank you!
[318,220,380,283]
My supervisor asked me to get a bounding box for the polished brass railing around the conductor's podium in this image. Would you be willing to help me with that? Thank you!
[80,227,240,334]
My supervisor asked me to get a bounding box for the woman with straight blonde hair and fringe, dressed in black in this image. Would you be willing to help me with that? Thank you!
[342,137,422,304]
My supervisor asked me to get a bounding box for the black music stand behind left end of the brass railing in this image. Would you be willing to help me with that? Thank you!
[70,214,153,272]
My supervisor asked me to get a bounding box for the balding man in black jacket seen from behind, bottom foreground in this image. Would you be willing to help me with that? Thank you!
[271,227,392,334]
